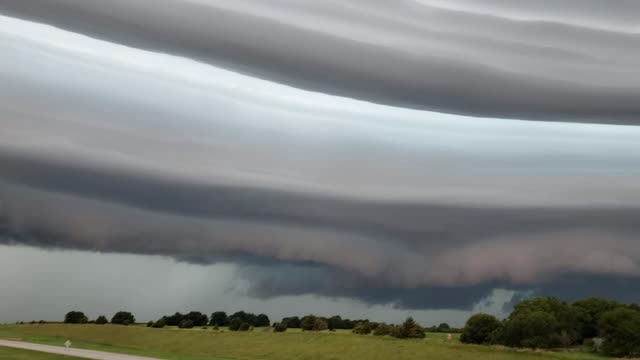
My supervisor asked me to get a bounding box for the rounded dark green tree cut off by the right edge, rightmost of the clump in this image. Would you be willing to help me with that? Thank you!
[598,307,640,357]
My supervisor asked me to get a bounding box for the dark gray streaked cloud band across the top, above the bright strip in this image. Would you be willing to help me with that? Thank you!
[0,0,640,124]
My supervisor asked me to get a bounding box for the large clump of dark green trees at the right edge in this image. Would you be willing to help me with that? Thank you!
[460,297,640,357]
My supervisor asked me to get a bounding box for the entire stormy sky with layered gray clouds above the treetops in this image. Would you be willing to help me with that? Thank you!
[0,0,640,325]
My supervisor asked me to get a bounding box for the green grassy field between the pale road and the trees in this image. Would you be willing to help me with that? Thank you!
[0,324,603,360]
